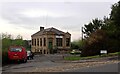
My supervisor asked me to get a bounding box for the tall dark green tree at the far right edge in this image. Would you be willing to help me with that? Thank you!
[108,1,120,52]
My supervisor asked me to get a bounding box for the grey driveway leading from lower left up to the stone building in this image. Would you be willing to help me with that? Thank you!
[2,55,64,72]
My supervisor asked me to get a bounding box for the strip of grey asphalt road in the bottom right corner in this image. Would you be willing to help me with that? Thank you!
[67,63,119,72]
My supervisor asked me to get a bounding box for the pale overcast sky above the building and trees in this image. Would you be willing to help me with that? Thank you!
[0,0,118,41]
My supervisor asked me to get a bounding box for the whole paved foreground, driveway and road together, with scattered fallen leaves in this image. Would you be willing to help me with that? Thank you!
[2,54,118,72]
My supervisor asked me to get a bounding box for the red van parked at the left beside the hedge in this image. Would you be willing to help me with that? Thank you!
[8,46,27,62]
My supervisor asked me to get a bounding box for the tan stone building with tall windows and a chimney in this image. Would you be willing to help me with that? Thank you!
[31,27,71,54]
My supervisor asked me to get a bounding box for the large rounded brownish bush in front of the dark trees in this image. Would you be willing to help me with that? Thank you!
[82,29,107,56]
